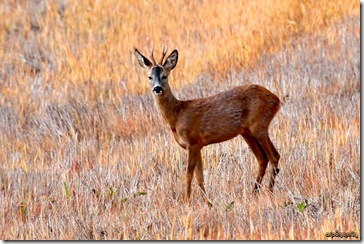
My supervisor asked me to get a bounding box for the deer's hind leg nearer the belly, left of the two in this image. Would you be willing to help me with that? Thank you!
[241,132,269,192]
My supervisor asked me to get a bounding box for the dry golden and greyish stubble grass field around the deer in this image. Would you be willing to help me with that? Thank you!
[0,0,361,240]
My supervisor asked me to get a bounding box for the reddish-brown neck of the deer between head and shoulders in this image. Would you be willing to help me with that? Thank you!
[156,87,181,129]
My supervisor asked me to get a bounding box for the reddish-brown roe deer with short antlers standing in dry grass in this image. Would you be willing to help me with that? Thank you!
[135,45,280,200]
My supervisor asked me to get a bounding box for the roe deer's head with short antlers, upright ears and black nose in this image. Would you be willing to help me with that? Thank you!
[134,47,178,96]
